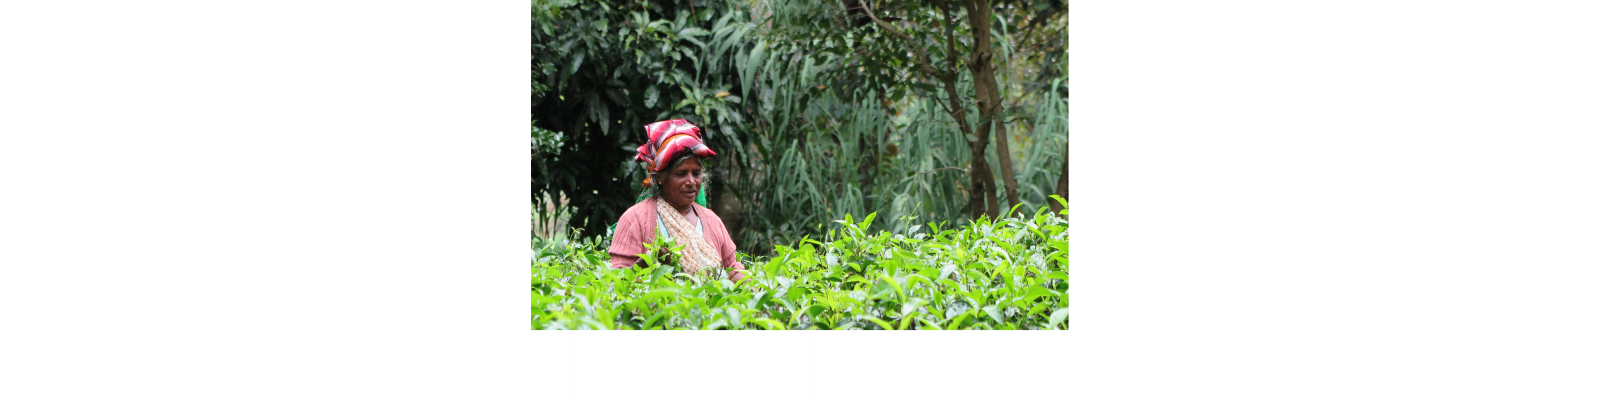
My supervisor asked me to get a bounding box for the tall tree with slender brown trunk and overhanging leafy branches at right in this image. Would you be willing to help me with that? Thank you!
[773,0,1066,219]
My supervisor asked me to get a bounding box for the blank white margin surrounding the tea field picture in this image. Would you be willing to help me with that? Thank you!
[0,0,1600,398]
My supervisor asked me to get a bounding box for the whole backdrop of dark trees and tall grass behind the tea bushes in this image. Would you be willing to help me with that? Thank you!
[531,0,1067,254]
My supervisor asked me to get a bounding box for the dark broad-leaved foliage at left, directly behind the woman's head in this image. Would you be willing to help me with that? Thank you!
[531,0,750,237]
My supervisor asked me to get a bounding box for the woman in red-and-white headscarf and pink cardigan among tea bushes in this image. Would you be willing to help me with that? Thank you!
[610,120,744,282]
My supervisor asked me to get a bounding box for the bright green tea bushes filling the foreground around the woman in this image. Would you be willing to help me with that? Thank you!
[533,197,1067,330]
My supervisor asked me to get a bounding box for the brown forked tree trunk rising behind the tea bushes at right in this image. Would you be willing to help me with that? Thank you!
[963,0,1021,216]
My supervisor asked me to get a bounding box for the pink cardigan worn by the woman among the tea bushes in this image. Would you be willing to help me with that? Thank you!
[608,197,744,282]
